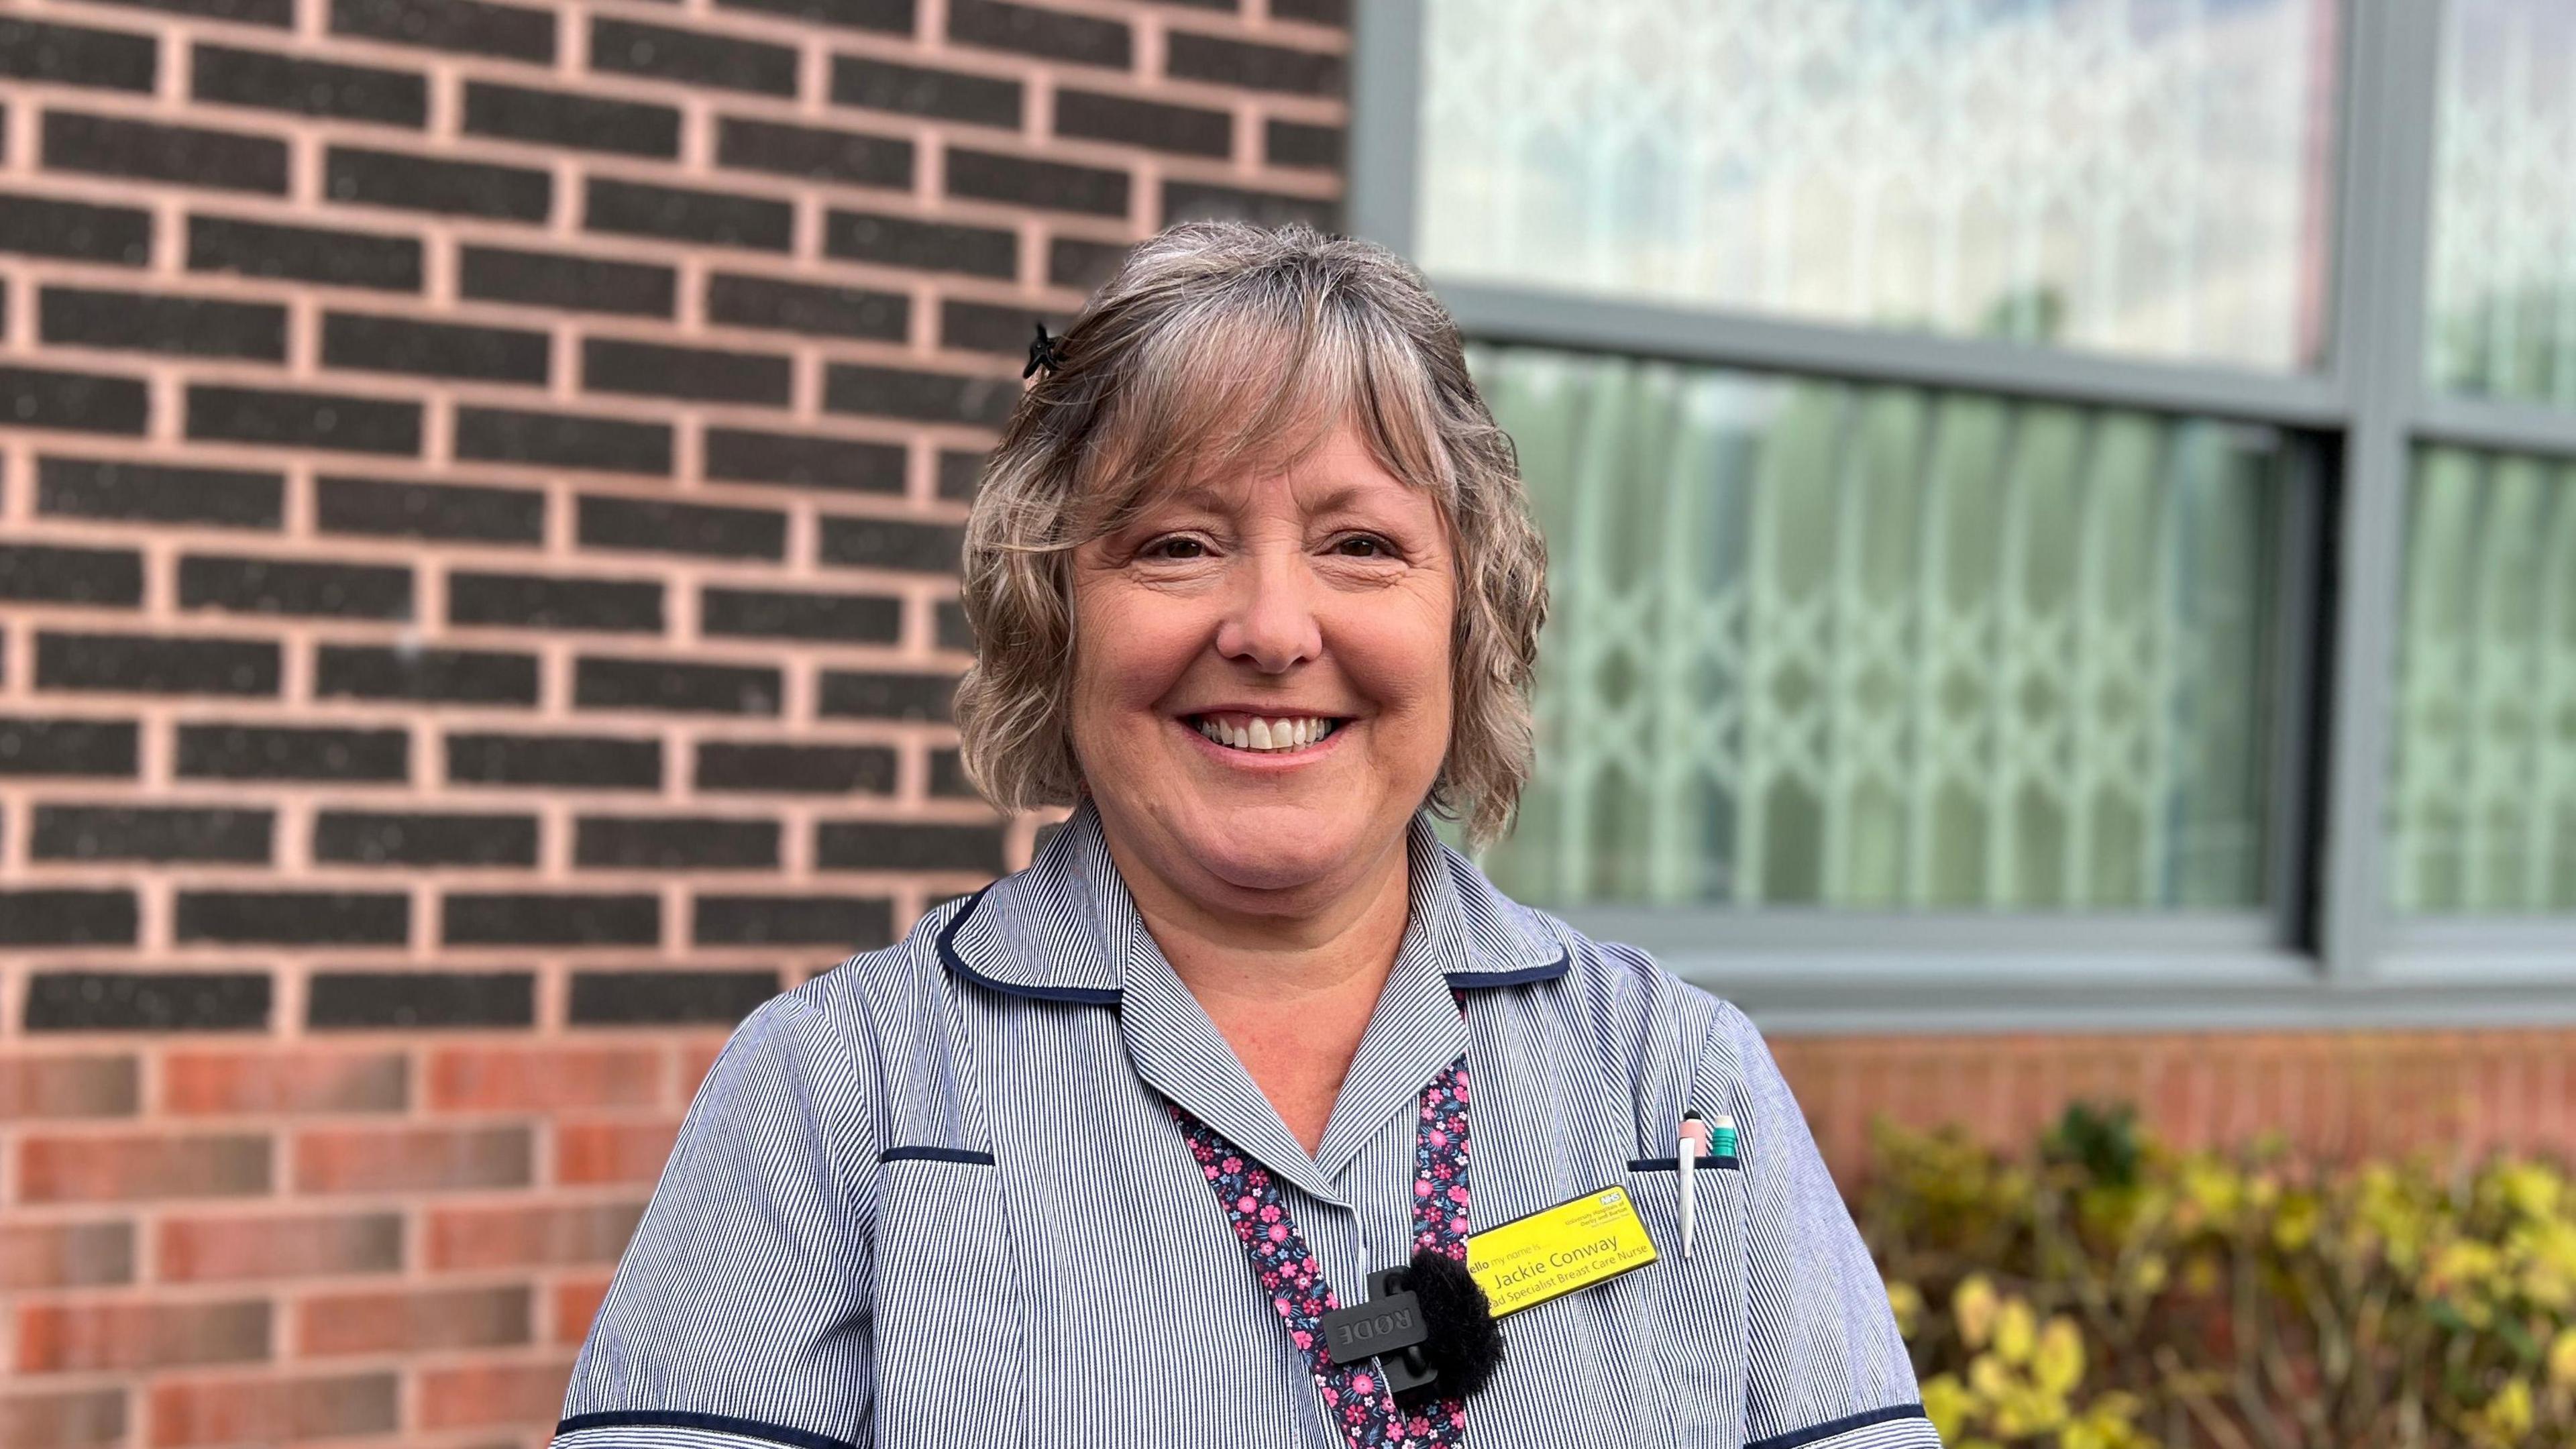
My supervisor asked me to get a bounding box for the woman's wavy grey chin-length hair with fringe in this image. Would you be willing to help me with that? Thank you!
[956,222,1548,843]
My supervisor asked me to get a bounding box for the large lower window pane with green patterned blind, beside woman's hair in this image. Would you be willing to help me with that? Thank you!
[1471,345,2290,910]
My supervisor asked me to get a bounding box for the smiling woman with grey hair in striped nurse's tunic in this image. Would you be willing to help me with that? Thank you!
[556,222,1937,1449]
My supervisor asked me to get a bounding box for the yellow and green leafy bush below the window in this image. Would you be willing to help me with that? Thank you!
[1855,1106,2576,1449]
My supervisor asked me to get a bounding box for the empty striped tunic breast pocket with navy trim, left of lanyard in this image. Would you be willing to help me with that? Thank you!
[876,1147,1025,1449]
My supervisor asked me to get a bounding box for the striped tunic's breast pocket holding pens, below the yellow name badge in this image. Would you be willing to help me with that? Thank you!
[1628,1158,1744,1449]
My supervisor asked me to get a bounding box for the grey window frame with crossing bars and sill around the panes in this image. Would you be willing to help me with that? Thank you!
[1344,0,2576,1031]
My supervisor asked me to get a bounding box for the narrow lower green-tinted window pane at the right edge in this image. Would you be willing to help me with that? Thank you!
[2391,449,2576,913]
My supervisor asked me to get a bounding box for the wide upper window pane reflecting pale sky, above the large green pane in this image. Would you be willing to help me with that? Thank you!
[1414,0,2337,369]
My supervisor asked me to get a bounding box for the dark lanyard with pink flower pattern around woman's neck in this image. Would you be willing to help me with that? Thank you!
[1169,1057,1468,1449]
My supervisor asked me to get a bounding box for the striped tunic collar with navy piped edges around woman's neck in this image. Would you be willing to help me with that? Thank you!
[938,802,1569,1201]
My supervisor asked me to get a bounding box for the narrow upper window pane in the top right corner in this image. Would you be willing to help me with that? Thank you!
[2424,0,2576,407]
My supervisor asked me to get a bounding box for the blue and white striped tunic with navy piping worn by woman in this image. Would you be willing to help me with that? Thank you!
[554,807,1940,1449]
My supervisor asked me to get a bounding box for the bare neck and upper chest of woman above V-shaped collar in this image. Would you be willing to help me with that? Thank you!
[1110,838,1411,1155]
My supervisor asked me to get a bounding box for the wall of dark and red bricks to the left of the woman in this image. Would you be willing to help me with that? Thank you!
[0,0,1347,1449]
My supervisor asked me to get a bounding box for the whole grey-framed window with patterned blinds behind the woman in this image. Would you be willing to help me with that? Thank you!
[1350,0,2576,1026]
